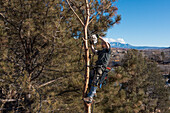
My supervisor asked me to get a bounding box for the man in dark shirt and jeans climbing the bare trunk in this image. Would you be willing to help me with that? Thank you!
[84,35,111,103]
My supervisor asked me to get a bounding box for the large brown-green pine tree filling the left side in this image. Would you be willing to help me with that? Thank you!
[0,0,80,112]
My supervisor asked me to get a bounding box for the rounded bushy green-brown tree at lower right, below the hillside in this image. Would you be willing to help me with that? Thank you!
[80,50,170,113]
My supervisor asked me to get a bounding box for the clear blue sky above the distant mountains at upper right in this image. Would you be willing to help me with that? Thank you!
[106,0,170,47]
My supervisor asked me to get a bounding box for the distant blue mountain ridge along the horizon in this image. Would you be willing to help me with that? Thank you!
[110,42,168,49]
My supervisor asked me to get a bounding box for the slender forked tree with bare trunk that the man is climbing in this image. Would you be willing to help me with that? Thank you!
[66,0,121,113]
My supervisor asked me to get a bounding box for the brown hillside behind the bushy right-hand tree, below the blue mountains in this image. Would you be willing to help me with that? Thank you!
[109,48,170,74]
